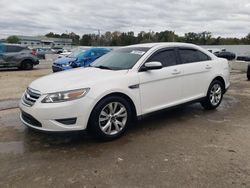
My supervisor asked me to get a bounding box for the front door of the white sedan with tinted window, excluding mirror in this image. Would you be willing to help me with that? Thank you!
[138,48,182,114]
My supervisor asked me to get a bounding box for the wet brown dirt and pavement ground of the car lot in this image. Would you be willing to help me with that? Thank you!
[0,57,250,188]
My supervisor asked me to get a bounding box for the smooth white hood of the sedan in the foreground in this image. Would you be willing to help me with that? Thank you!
[29,67,128,94]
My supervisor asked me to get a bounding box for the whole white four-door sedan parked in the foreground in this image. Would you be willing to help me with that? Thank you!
[20,43,229,140]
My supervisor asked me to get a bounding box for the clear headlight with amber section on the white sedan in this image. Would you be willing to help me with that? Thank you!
[42,88,89,103]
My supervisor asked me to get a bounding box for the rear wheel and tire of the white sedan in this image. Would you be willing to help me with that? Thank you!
[201,80,225,110]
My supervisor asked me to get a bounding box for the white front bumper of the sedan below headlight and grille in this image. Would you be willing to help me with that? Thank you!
[19,96,95,132]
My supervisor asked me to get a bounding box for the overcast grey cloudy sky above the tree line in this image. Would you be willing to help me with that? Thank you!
[0,0,250,38]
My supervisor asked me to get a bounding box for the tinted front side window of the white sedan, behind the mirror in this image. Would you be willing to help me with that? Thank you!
[148,50,177,67]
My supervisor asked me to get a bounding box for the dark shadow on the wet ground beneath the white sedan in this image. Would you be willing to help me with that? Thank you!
[21,104,203,147]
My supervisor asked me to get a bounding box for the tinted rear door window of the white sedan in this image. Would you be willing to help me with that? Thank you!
[179,49,211,63]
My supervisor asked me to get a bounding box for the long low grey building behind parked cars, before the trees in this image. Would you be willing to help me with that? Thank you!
[17,35,72,48]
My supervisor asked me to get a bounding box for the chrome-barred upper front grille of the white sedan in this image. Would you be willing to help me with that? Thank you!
[22,88,41,106]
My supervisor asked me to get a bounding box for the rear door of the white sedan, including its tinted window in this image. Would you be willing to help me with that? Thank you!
[178,48,213,102]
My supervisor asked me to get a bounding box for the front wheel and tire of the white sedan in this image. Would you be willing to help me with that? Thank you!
[88,96,132,141]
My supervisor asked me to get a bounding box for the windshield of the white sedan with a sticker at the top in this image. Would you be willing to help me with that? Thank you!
[91,47,149,70]
